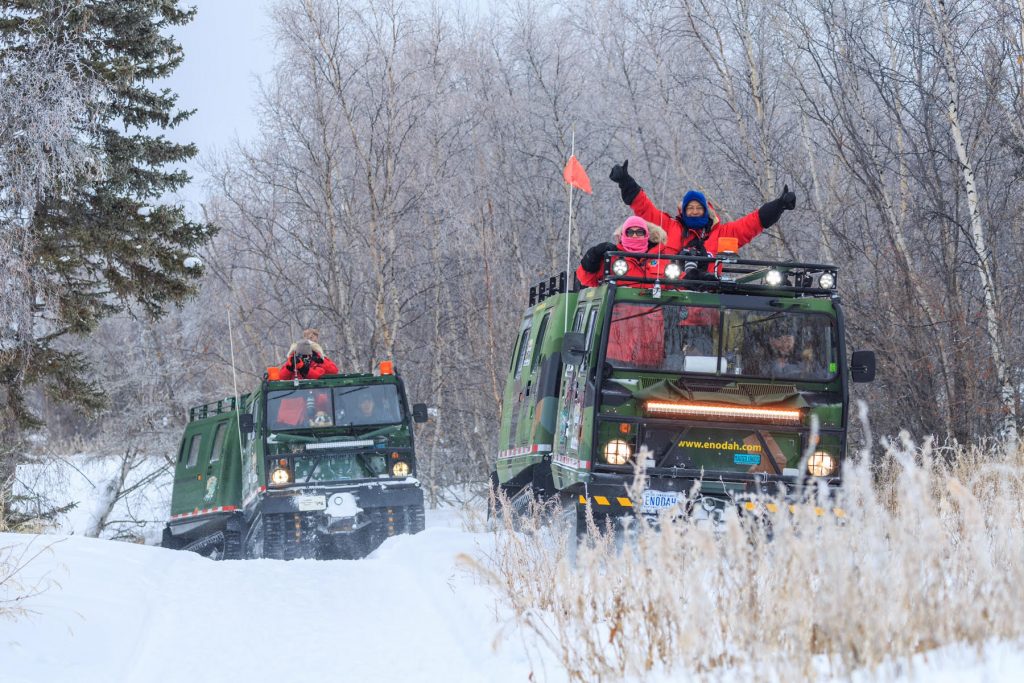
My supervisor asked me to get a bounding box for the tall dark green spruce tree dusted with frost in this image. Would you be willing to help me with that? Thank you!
[0,0,213,491]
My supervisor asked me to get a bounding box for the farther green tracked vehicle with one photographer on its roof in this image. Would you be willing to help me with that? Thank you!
[161,361,427,559]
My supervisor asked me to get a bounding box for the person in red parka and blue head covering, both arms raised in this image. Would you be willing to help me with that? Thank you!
[608,160,797,257]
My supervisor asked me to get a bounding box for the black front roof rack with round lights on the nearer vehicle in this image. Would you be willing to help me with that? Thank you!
[601,251,839,297]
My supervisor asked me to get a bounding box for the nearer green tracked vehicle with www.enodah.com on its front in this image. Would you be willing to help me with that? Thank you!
[492,252,874,532]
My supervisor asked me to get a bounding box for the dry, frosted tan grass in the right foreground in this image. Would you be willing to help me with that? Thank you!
[475,437,1024,681]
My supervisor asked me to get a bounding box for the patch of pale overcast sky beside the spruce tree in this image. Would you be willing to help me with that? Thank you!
[160,0,274,218]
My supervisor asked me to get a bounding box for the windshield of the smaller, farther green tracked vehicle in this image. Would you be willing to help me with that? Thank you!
[266,384,402,431]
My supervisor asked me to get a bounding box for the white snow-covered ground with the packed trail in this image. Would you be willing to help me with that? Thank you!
[6,456,1024,683]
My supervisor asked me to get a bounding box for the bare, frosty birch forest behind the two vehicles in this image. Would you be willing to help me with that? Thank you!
[7,0,1024,501]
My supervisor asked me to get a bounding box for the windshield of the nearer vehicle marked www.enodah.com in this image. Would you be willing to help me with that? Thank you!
[605,303,838,382]
